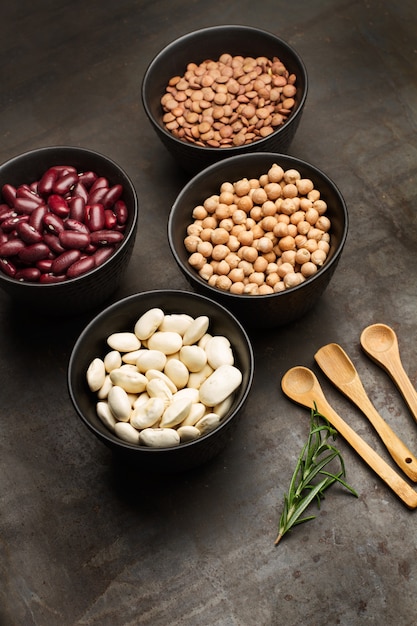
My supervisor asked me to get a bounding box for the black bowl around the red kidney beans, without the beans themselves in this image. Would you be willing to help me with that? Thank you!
[0,146,139,315]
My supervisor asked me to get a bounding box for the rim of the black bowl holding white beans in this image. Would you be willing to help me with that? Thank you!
[67,289,255,455]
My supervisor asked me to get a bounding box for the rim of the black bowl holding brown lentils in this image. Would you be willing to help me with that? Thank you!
[141,24,309,156]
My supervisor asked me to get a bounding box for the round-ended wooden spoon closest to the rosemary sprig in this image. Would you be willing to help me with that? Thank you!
[281,366,417,509]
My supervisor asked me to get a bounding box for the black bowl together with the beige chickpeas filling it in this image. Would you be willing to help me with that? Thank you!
[168,153,348,328]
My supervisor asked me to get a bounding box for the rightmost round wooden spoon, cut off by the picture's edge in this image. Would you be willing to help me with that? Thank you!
[360,324,417,421]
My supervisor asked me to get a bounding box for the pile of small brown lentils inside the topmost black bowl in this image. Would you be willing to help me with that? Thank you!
[161,54,297,148]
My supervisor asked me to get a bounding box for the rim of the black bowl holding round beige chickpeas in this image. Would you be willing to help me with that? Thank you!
[167,152,349,302]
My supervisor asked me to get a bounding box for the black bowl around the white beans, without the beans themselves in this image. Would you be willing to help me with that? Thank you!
[68,290,254,473]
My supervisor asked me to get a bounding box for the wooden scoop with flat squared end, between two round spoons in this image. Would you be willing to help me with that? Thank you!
[314,343,417,482]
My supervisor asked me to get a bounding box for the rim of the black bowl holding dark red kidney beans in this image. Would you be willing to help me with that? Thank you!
[0,144,139,292]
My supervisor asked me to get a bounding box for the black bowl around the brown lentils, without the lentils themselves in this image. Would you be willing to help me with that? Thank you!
[142,25,308,174]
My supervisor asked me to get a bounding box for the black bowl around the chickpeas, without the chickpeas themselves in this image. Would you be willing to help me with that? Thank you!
[168,153,348,329]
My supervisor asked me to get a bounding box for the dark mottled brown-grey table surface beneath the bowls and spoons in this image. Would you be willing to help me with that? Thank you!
[0,0,417,626]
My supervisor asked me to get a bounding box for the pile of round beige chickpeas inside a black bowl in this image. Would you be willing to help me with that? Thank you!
[184,163,331,295]
